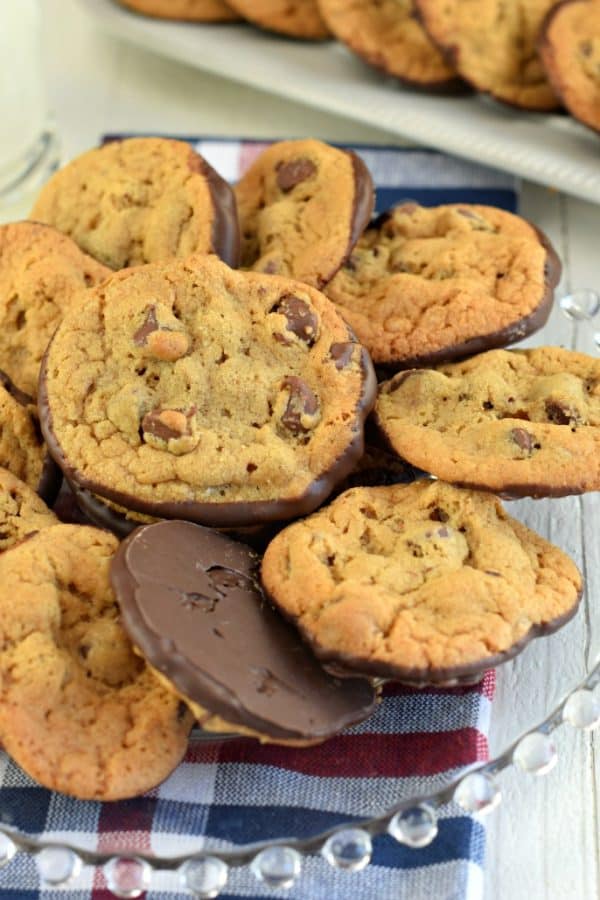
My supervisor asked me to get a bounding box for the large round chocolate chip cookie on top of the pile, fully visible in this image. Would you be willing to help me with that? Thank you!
[40,256,375,528]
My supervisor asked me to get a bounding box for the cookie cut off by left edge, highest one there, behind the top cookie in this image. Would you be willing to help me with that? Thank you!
[0,222,111,397]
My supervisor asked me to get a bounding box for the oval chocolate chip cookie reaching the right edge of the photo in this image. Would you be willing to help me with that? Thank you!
[376,347,600,497]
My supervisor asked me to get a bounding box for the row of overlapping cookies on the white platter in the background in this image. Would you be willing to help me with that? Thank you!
[117,0,600,131]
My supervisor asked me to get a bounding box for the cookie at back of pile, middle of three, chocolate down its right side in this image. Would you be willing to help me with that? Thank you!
[235,140,374,288]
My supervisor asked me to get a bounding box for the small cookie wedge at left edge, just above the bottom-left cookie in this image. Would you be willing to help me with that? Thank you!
[0,468,58,552]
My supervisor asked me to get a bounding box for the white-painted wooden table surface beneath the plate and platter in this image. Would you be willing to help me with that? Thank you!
[31,0,600,900]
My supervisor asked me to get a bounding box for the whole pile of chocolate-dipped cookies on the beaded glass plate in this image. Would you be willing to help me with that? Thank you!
[0,138,600,799]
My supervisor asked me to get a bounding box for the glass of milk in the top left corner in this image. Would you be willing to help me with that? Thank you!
[0,0,58,218]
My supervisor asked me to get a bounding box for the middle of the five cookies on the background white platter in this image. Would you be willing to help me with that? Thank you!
[319,0,463,91]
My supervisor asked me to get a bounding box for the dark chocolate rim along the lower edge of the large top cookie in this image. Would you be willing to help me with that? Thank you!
[38,347,377,528]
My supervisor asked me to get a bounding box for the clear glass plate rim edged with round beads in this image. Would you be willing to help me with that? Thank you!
[0,288,600,898]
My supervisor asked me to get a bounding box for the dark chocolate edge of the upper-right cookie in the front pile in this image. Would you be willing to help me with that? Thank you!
[373,221,562,381]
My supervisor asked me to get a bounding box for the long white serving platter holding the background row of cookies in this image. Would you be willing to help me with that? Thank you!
[79,0,600,203]
